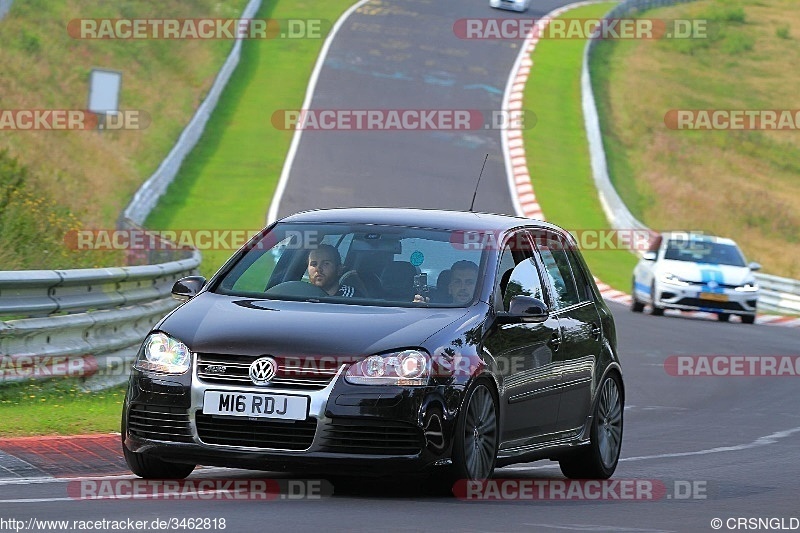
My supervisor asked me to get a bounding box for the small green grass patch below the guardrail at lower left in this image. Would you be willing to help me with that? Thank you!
[0,380,125,437]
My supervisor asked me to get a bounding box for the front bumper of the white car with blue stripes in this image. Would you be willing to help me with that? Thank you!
[654,282,758,315]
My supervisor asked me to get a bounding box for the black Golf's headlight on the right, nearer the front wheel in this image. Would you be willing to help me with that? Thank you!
[345,350,430,385]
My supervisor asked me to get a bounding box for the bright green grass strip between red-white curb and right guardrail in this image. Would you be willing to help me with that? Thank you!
[523,2,636,291]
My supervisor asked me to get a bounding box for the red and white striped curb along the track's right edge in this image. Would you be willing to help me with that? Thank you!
[501,1,800,327]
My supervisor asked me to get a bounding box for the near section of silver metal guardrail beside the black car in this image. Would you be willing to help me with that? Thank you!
[0,250,200,389]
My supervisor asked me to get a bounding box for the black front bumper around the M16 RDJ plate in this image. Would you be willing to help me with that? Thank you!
[123,367,457,473]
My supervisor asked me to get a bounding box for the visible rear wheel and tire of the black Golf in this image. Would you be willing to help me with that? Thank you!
[558,374,624,479]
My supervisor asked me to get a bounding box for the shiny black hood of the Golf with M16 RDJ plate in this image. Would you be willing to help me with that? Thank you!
[158,292,468,359]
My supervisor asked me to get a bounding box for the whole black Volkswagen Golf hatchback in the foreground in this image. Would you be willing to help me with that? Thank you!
[122,208,624,479]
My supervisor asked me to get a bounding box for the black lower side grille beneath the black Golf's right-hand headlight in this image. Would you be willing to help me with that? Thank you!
[322,419,423,455]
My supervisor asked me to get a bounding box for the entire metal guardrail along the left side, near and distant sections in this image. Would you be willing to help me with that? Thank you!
[0,0,261,389]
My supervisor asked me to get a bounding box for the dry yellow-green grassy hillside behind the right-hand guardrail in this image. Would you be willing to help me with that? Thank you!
[592,0,800,278]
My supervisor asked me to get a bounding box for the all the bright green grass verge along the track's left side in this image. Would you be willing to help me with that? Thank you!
[0,0,354,437]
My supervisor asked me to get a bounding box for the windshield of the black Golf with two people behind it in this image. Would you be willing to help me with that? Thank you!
[212,223,485,307]
